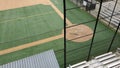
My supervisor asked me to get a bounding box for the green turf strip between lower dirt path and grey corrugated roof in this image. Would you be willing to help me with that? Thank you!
[0,38,64,68]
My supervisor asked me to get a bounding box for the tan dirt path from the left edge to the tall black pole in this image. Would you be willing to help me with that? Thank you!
[0,34,64,55]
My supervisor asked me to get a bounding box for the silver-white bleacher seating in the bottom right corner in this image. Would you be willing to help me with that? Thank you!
[68,48,120,68]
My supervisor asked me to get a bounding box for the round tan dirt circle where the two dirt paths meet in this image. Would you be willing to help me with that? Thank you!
[66,24,93,42]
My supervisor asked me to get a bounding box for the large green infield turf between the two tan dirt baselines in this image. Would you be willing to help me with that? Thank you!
[0,5,63,50]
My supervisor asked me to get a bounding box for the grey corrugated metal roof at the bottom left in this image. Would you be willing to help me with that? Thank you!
[1,50,60,68]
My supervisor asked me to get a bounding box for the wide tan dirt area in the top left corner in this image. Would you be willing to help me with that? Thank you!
[0,0,49,10]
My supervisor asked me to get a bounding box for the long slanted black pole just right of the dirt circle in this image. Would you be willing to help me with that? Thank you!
[87,0,103,61]
